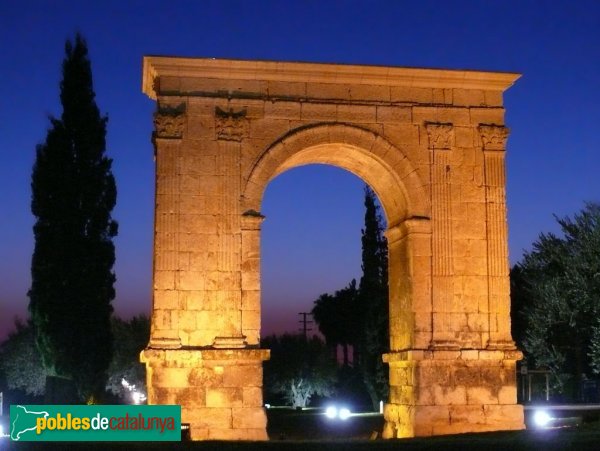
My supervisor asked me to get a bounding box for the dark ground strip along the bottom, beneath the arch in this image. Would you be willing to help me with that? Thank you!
[7,411,600,451]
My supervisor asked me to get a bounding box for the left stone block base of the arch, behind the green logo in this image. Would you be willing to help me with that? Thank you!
[140,348,269,440]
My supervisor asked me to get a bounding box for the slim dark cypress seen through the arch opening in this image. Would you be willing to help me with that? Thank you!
[355,186,389,408]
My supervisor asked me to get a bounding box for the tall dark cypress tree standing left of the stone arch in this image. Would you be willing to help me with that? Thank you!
[29,35,117,399]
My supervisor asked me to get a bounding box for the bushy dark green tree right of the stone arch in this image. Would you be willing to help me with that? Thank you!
[512,203,600,396]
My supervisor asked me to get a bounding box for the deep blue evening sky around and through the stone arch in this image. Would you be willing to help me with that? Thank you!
[0,0,600,339]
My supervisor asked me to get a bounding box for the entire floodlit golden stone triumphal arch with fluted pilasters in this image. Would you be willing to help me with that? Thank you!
[141,57,523,440]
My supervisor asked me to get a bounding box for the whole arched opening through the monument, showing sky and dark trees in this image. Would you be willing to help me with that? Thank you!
[261,164,389,416]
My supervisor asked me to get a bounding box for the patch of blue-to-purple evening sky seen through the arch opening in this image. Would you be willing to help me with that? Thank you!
[261,165,365,338]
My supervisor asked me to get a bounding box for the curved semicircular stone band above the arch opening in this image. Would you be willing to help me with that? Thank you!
[242,123,429,227]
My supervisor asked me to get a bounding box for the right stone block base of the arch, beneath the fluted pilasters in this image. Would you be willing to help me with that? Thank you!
[383,349,525,438]
